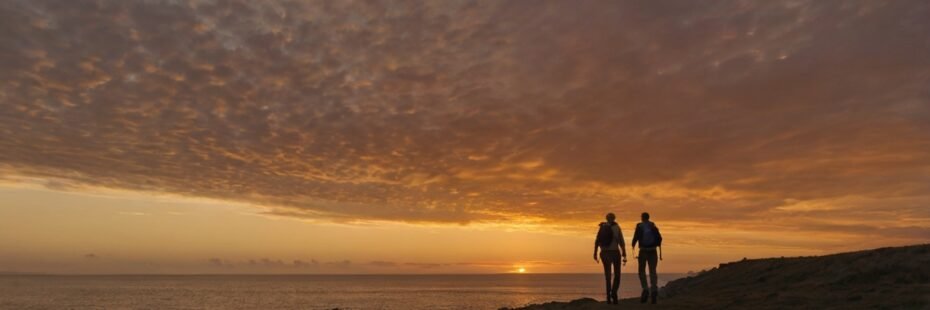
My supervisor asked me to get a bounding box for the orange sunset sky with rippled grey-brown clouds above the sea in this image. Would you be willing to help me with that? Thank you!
[0,0,930,273]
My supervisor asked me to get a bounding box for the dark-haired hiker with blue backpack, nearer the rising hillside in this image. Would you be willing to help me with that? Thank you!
[631,212,662,303]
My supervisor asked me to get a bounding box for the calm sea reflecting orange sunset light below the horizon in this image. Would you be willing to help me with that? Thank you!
[0,274,684,310]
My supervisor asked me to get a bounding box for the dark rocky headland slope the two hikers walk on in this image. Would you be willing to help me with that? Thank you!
[508,245,930,310]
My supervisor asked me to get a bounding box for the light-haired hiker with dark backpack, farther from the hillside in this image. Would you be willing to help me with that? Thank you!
[594,213,626,304]
